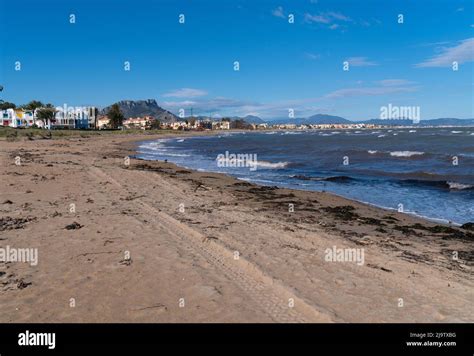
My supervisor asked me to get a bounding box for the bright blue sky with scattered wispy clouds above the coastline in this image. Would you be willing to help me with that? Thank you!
[0,0,474,120]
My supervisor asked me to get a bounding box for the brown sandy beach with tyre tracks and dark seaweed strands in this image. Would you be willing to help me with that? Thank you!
[0,135,474,323]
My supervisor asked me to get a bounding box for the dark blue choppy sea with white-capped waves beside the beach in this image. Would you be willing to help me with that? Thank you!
[138,128,474,224]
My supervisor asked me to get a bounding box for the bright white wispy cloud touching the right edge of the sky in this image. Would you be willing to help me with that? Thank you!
[415,37,474,68]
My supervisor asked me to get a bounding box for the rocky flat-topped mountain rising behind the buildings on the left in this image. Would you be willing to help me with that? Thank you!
[101,99,178,122]
